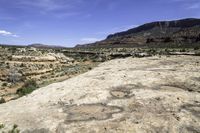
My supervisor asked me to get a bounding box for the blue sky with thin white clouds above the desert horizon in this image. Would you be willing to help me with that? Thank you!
[0,0,200,47]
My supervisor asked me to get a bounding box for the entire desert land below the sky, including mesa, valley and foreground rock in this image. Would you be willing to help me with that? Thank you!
[0,18,200,133]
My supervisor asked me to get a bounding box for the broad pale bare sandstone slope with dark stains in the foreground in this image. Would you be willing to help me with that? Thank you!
[0,56,200,133]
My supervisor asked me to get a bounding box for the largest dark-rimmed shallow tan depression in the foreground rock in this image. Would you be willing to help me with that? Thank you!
[64,103,123,123]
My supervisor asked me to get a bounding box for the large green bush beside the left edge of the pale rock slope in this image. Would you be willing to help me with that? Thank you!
[17,80,39,96]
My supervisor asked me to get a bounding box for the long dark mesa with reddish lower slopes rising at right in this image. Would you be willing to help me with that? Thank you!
[77,18,200,47]
